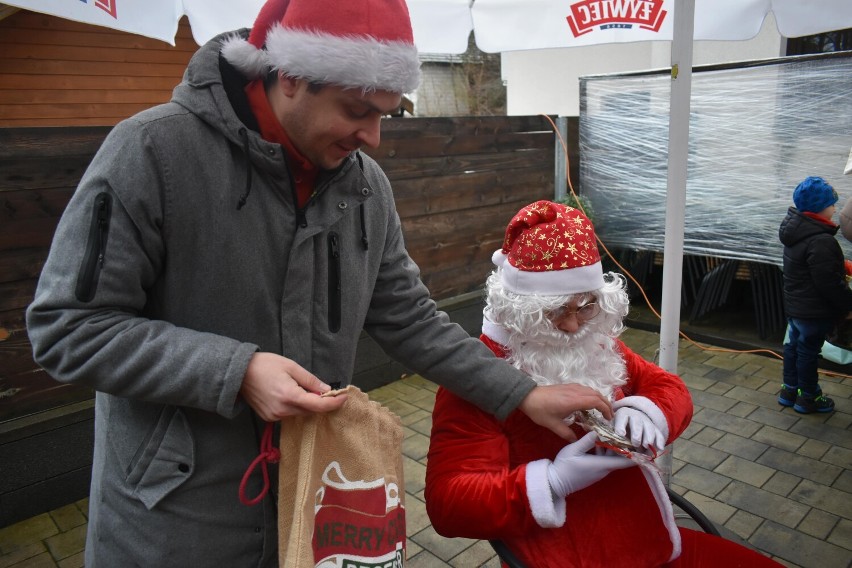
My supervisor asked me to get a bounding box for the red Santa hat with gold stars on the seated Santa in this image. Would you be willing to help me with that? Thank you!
[491,201,604,296]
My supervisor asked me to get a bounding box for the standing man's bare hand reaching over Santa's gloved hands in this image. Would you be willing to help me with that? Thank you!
[518,384,612,441]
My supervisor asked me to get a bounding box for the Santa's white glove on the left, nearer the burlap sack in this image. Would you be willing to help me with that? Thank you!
[547,432,636,499]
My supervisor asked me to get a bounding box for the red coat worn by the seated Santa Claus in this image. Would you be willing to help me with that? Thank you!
[426,336,692,568]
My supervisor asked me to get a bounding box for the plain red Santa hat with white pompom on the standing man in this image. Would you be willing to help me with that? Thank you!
[222,0,420,94]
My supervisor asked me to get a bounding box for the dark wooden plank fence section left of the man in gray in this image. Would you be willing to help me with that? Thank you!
[0,127,109,422]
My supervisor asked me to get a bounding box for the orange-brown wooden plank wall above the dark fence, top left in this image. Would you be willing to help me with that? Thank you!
[0,10,198,127]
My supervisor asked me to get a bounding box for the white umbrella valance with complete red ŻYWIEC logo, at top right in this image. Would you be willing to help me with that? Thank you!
[471,0,852,52]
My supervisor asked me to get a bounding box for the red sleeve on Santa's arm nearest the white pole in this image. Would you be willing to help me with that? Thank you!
[618,341,693,443]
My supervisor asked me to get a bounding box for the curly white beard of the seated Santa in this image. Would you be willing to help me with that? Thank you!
[505,320,627,400]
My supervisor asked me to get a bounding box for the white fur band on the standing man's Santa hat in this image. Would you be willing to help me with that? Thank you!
[266,24,420,94]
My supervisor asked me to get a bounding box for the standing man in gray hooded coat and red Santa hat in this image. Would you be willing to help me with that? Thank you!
[27,0,610,568]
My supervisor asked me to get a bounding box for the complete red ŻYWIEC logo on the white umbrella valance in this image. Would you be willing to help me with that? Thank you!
[567,0,667,37]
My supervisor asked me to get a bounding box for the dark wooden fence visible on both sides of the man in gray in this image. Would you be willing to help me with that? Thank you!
[0,117,578,527]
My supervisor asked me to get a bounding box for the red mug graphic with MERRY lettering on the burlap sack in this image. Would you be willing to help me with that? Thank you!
[311,461,405,568]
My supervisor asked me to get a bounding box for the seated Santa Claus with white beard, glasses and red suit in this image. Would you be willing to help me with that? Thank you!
[425,201,777,568]
